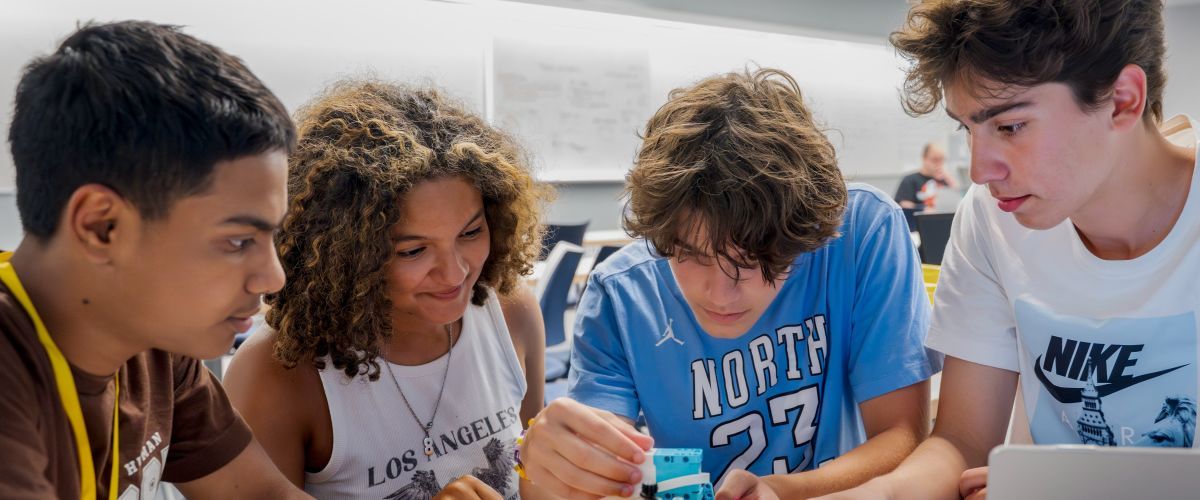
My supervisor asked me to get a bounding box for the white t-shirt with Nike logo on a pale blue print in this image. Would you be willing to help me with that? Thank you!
[926,116,1200,447]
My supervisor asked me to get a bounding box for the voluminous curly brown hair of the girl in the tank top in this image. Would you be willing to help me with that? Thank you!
[266,80,552,380]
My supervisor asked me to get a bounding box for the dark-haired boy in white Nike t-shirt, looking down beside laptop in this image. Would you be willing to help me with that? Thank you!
[842,0,1200,499]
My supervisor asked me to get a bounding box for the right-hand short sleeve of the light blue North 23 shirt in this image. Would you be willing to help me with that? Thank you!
[850,194,941,403]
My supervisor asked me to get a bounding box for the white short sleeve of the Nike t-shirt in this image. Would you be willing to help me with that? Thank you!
[926,186,1019,372]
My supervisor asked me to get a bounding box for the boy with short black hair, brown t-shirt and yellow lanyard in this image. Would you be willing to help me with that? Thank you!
[0,22,305,499]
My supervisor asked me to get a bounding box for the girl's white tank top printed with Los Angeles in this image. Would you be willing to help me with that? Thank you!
[305,290,526,500]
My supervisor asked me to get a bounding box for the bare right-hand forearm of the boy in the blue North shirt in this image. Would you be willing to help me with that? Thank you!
[763,426,924,499]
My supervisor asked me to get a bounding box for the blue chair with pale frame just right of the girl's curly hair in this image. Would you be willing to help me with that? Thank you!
[535,241,583,381]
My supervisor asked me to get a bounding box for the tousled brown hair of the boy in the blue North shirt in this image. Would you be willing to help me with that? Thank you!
[625,68,847,282]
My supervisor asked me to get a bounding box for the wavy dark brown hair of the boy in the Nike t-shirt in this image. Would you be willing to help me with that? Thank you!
[890,0,1166,121]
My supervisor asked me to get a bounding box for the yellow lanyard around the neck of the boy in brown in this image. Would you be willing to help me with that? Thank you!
[0,252,121,500]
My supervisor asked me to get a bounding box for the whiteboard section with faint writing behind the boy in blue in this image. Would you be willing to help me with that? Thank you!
[488,1,955,181]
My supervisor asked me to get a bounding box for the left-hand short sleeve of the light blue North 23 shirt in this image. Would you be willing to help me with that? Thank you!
[568,275,641,420]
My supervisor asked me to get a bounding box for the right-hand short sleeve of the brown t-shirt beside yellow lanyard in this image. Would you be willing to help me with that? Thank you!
[162,356,253,482]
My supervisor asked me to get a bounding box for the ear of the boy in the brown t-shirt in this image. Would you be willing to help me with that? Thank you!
[62,183,137,264]
